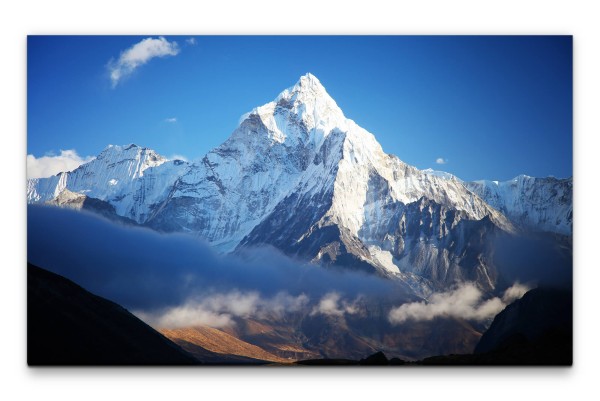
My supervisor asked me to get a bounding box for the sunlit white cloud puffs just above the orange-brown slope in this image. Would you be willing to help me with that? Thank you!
[135,291,308,329]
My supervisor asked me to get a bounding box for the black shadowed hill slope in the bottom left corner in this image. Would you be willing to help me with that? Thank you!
[27,264,199,366]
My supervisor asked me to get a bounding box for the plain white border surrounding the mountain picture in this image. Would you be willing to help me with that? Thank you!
[5,0,600,401]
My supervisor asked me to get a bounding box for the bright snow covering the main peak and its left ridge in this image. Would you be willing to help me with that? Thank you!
[27,73,556,258]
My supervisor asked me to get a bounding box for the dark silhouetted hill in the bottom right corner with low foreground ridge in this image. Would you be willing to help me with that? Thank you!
[297,288,573,366]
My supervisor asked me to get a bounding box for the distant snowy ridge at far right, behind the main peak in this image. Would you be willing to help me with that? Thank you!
[465,175,573,236]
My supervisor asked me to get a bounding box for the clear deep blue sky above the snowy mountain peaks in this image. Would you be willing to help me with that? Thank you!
[27,35,573,180]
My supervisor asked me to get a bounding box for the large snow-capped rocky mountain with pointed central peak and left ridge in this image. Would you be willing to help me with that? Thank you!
[27,74,572,296]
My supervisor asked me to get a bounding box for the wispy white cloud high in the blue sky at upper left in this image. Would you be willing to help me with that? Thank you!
[108,36,179,88]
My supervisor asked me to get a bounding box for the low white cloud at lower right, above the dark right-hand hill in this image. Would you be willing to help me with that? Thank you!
[388,283,529,324]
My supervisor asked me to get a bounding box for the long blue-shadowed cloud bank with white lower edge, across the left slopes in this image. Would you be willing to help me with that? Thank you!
[27,206,406,327]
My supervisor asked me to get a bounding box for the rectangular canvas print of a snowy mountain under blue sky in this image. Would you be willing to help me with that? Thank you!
[27,35,573,367]
